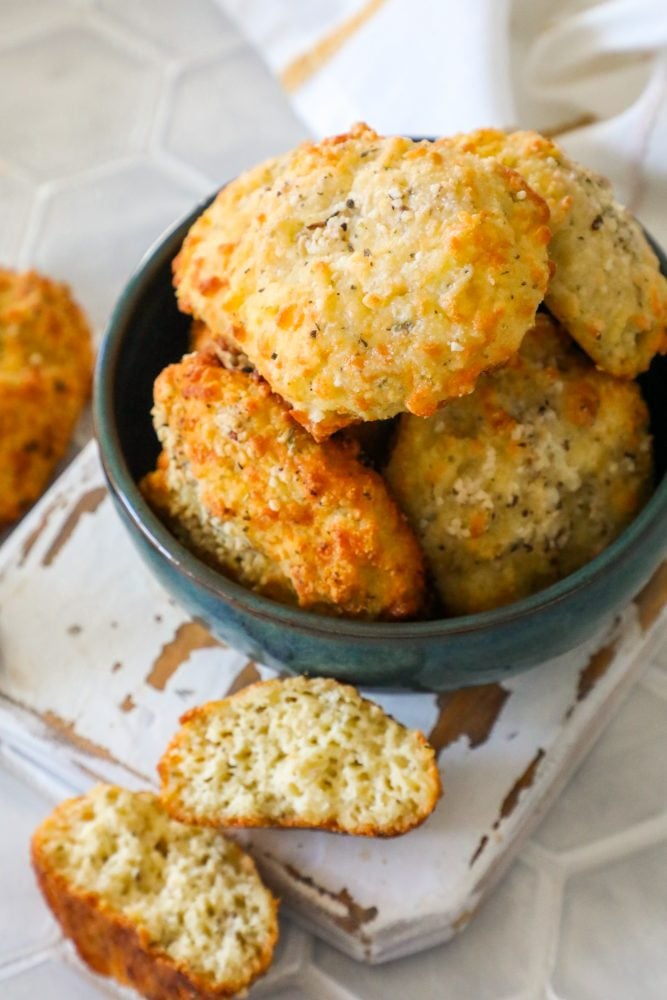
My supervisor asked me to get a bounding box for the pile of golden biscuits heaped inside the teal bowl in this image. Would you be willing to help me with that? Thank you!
[142,125,667,621]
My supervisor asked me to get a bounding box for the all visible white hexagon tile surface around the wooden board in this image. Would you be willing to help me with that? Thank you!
[0,0,667,1000]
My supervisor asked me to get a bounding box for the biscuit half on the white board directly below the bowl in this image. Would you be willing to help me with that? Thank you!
[158,677,441,837]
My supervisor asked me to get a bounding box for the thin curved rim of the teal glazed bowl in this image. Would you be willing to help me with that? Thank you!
[93,195,667,643]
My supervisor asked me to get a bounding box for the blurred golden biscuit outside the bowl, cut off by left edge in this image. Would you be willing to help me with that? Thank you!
[0,269,92,525]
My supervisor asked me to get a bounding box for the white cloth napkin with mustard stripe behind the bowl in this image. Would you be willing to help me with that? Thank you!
[218,0,667,245]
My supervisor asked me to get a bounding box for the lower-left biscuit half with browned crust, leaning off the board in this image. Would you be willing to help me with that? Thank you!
[32,785,278,1000]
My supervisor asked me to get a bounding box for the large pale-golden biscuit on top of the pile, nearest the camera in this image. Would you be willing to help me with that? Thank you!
[174,125,549,440]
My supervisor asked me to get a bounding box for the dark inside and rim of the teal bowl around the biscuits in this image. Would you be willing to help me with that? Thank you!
[95,199,667,636]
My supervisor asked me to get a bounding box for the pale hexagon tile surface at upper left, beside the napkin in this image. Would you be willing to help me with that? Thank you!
[0,0,306,332]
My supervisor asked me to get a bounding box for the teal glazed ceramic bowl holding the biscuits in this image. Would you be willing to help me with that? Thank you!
[94,199,667,691]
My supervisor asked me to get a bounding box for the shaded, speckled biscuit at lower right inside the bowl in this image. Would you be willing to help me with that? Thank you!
[387,315,652,615]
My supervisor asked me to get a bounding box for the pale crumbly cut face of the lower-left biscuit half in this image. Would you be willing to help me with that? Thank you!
[44,786,273,982]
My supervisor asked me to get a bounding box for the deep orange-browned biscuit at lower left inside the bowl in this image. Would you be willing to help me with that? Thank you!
[142,354,423,619]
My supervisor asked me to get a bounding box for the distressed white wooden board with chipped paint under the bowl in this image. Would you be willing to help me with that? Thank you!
[0,444,665,962]
